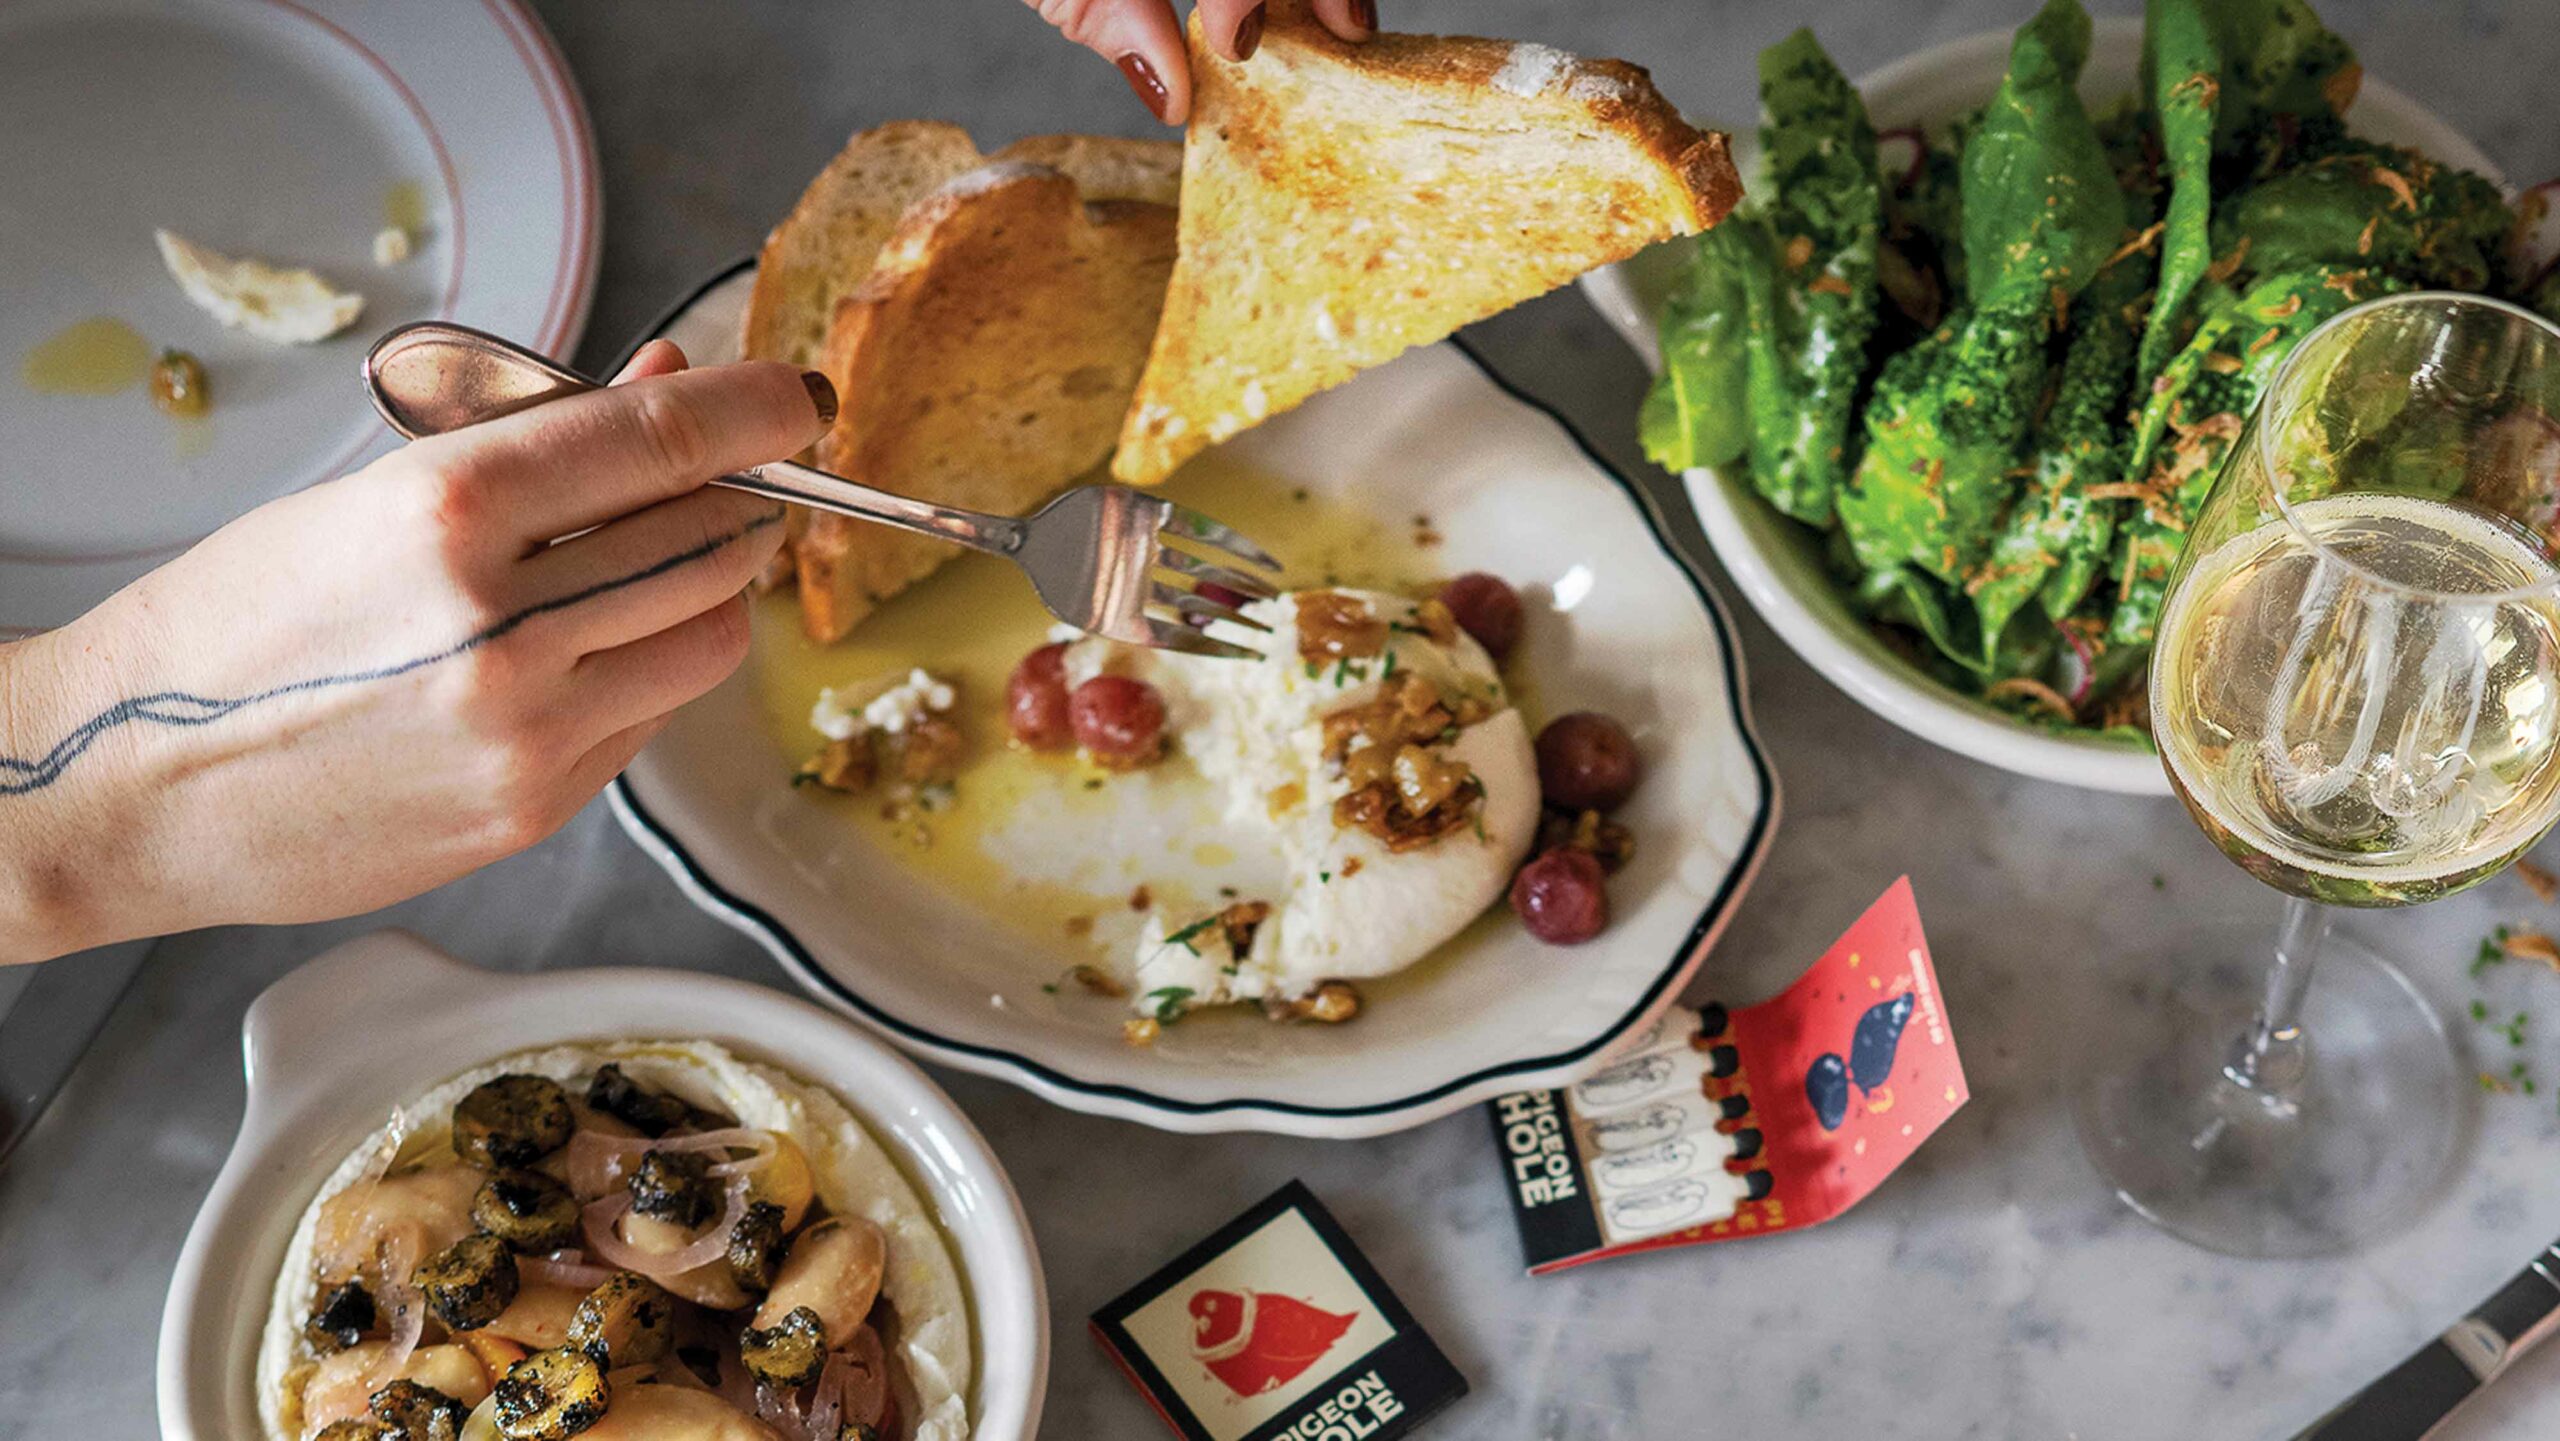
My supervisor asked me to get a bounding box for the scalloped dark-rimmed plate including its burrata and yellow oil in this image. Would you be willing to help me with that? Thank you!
[614,269,1777,1136]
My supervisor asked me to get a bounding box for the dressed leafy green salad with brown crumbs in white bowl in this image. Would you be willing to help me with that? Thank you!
[1641,0,2560,737]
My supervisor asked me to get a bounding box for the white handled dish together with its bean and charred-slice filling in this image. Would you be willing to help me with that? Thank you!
[159,932,1050,1441]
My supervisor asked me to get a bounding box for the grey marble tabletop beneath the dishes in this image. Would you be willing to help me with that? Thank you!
[0,0,2560,1441]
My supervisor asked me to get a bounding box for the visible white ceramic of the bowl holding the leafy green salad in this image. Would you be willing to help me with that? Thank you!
[1582,18,2499,796]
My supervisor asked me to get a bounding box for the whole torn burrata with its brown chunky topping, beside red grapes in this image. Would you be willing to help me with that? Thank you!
[1062,591,1539,1021]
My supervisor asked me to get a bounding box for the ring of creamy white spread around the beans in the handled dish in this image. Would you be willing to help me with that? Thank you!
[259,1042,970,1441]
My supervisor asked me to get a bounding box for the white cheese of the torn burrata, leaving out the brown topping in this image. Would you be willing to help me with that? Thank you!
[1065,591,1539,1016]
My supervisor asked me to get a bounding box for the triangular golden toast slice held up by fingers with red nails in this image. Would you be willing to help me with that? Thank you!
[1111,0,1741,484]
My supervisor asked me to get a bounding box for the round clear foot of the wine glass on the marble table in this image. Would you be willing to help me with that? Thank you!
[2074,934,2465,1257]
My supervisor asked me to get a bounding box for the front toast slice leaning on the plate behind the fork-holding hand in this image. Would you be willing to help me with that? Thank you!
[796,161,1175,642]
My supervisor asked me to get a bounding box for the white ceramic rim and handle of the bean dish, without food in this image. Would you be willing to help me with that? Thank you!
[159,932,1050,1441]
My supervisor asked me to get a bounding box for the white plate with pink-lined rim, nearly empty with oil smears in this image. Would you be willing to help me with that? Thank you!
[0,0,602,637]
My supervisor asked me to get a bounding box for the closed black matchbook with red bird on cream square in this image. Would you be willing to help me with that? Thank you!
[1093,1182,1467,1441]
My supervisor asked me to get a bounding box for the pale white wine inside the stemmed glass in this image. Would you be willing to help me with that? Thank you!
[2150,491,2560,906]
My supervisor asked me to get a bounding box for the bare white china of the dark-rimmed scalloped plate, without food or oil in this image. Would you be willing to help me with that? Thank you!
[614,269,1777,1136]
